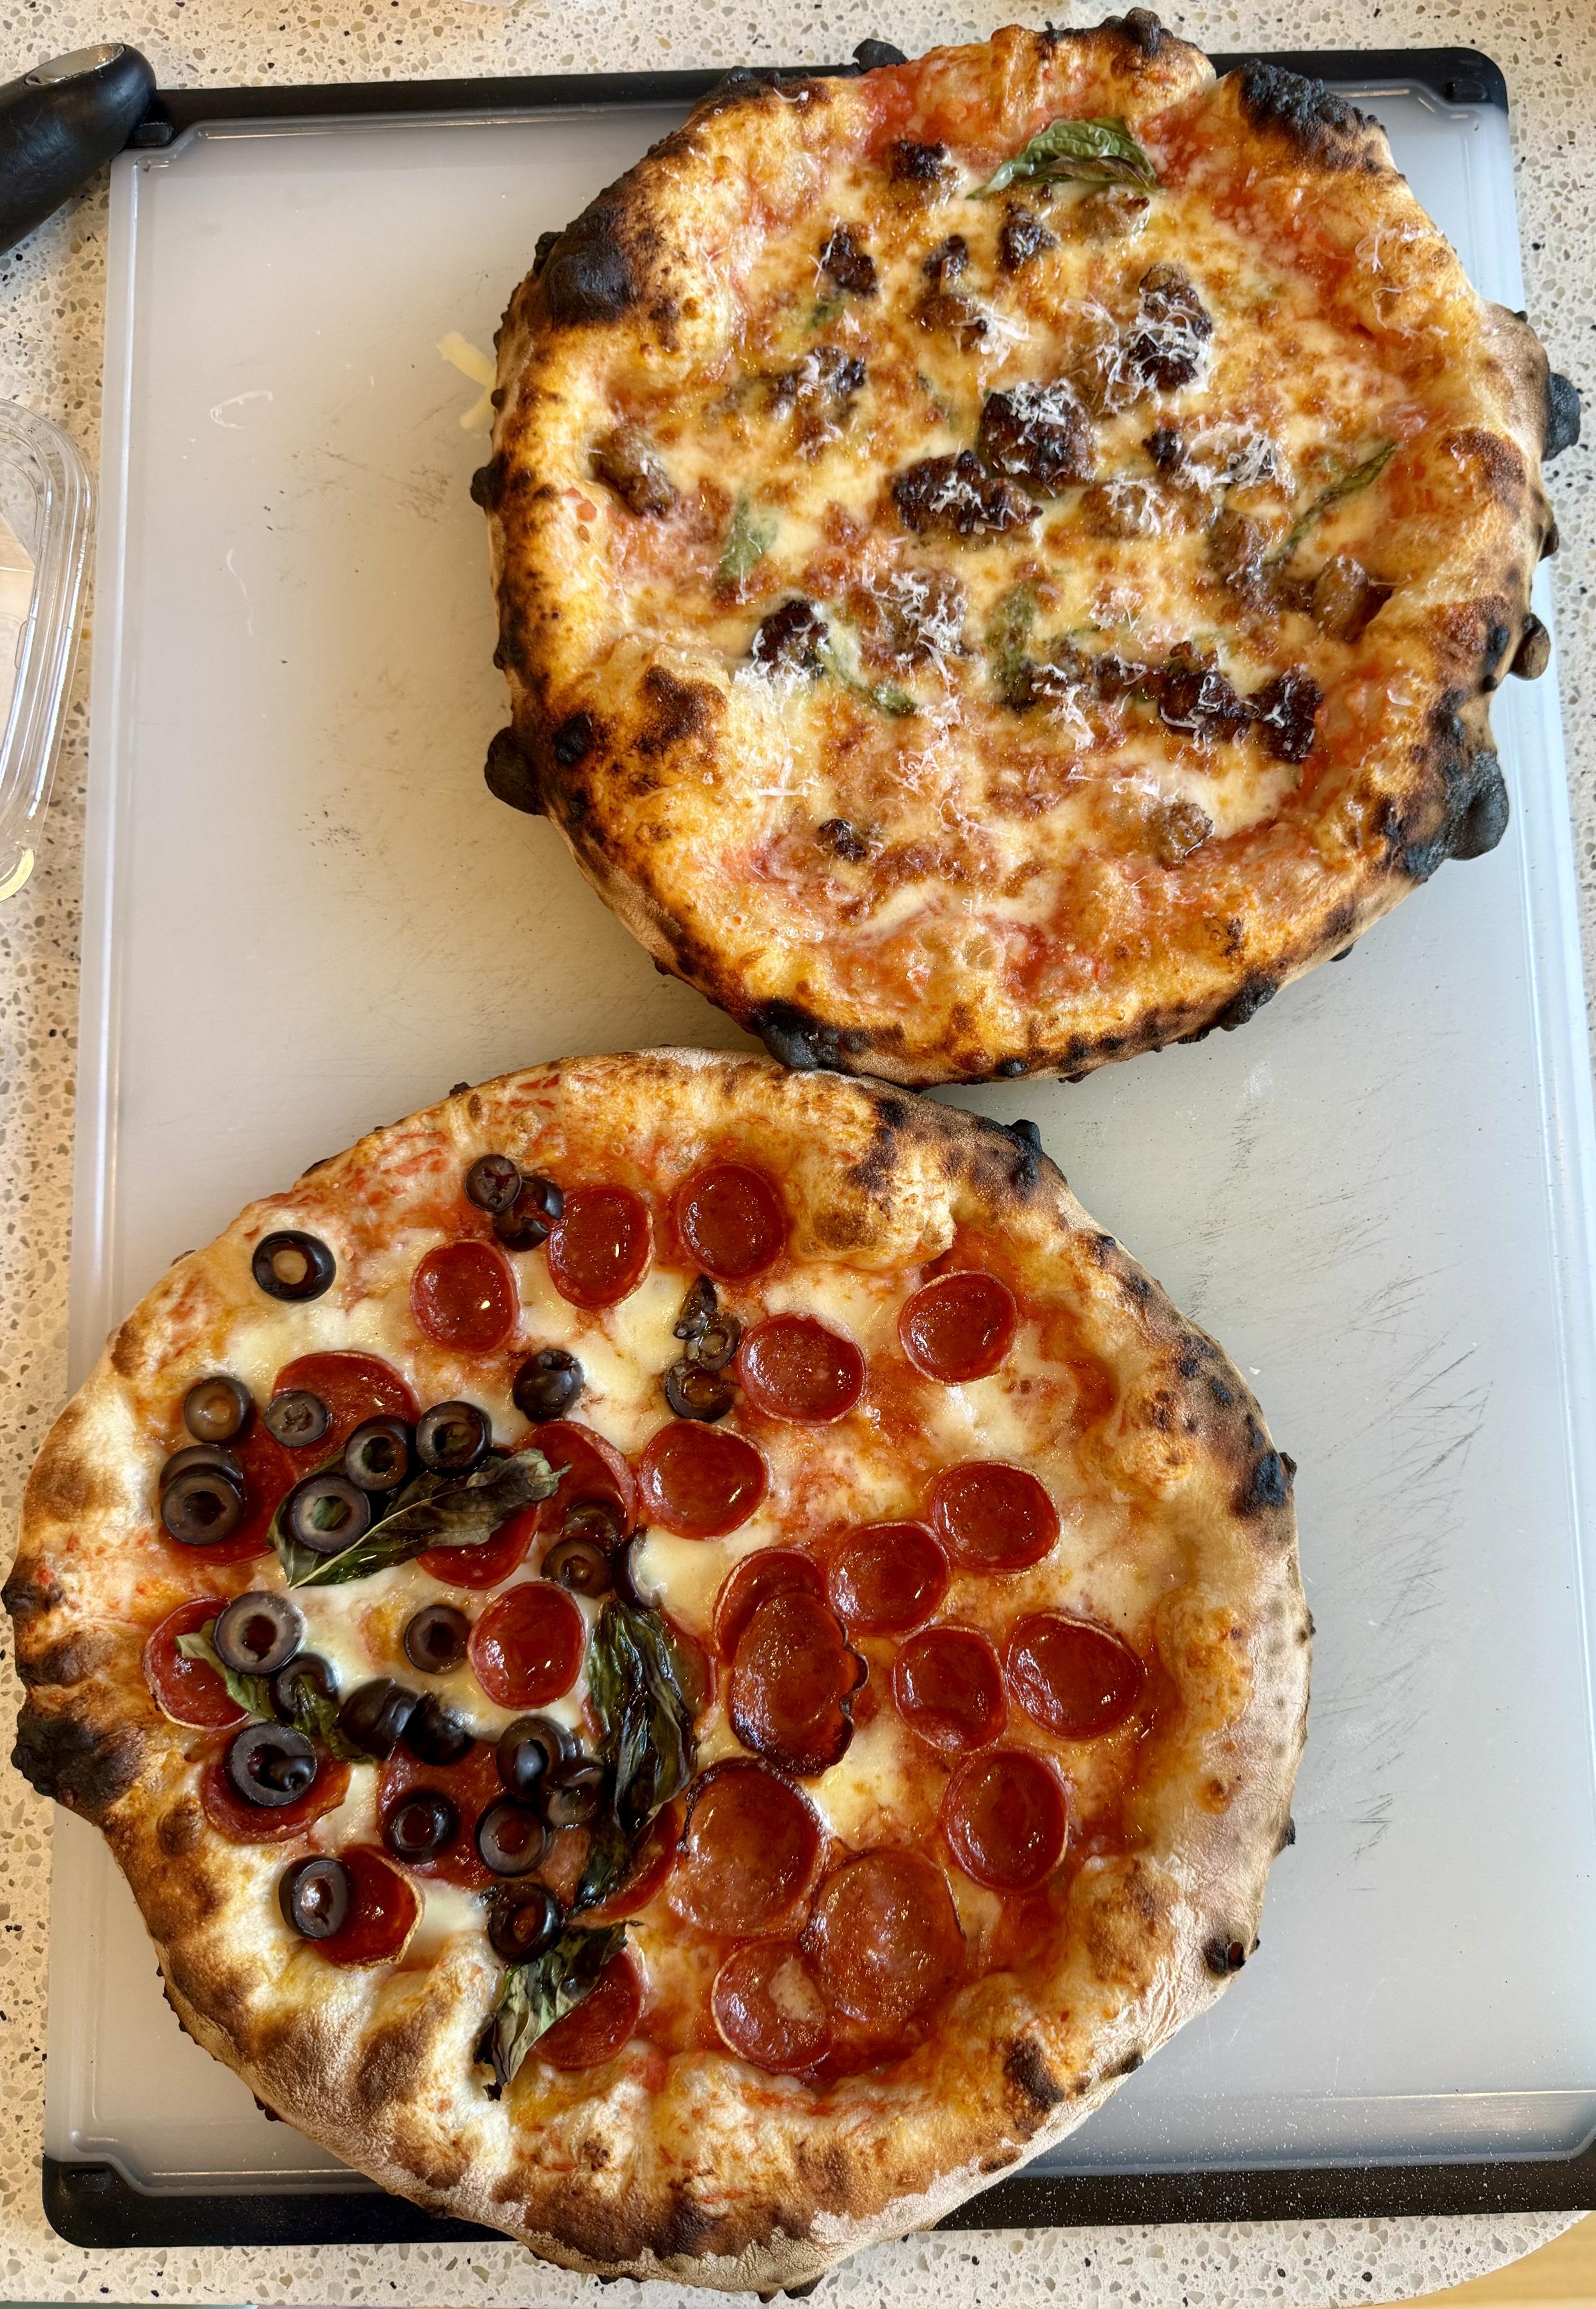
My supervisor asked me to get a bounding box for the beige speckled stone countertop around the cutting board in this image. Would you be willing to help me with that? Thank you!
[0,0,1596,2309]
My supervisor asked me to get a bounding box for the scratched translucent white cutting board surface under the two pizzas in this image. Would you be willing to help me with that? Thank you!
[46,77,1596,2186]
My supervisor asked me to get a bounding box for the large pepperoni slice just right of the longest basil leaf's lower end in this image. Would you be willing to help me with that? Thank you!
[670,1764,820,1940]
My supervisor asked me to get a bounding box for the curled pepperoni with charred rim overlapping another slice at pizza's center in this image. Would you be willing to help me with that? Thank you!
[728,1588,866,1778]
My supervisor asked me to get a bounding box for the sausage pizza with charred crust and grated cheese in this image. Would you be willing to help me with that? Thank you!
[476,11,1566,1085]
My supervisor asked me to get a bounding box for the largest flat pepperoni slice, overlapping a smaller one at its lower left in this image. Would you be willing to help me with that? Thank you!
[815,1847,963,2030]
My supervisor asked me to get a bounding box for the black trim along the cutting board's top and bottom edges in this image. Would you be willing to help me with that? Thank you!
[44,49,1552,2249]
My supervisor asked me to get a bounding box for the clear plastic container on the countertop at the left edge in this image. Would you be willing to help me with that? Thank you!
[0,402,95,905]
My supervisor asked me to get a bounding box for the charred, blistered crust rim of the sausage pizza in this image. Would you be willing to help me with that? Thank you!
[474,11,1557,1085]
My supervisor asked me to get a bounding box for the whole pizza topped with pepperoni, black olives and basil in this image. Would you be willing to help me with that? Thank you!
[5,1053,1307,2288]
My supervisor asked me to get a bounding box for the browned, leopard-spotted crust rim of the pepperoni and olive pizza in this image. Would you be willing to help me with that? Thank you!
[5,1051,1309,2288]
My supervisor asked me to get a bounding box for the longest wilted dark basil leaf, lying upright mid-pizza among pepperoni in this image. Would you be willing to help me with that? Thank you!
[570,1596,698,1914]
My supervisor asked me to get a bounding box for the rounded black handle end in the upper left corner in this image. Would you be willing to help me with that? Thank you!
[0,41,155,257]
